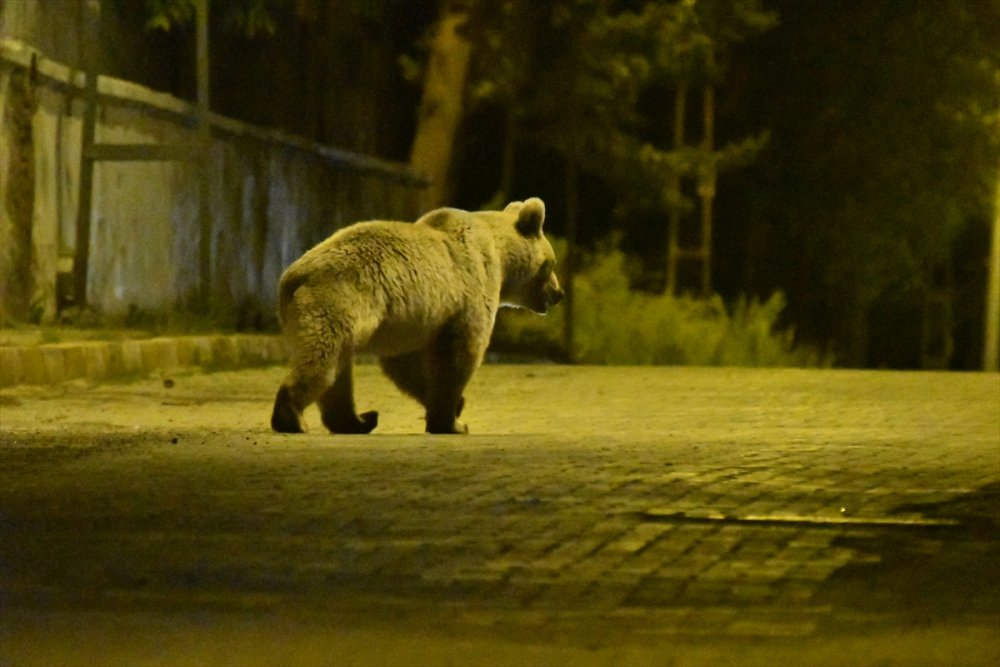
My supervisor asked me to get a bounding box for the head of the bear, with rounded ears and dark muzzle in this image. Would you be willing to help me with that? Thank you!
[499,197,564,315]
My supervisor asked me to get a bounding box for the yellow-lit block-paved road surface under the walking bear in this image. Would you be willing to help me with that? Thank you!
[0,366,1000,666]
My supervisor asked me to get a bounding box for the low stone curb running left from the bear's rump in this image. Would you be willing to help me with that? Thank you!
[0,335,287,389]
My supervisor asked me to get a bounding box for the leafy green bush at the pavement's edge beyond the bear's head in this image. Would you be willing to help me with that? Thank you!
[494,239,823,366]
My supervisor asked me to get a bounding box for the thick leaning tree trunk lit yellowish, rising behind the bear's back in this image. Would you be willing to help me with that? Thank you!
[410,0,472,209]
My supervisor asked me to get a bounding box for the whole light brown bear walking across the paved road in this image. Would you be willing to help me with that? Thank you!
[271,198,563,433]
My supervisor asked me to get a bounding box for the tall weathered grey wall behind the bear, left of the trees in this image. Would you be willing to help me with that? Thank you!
[0,38,421,325]
